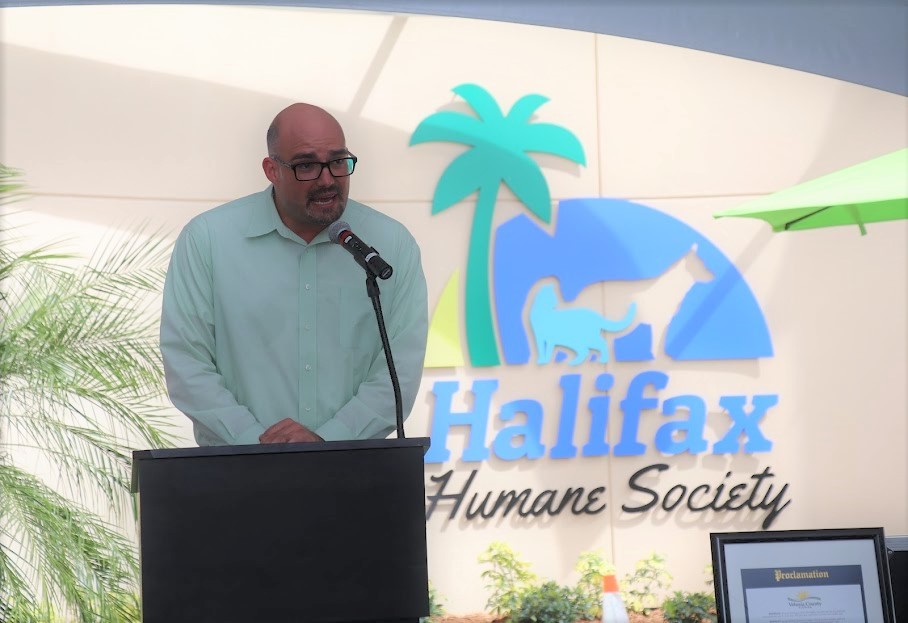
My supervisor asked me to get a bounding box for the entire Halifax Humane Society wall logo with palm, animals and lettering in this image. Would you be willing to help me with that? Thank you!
[410,84,787,521]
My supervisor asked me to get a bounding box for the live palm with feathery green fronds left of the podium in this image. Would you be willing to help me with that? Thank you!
[0,165,172,623]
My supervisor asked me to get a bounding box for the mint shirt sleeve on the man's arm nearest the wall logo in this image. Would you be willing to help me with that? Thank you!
[315,232,429,441]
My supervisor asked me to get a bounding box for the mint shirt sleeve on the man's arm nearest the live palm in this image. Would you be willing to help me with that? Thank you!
[161,219,265,445]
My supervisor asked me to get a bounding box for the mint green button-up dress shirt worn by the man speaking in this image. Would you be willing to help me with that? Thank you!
[161,187,428,446]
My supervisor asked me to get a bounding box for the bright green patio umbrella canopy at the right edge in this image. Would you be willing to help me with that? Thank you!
[713,148,908,235]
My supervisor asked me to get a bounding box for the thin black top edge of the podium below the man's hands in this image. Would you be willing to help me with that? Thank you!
[132,437,430,461]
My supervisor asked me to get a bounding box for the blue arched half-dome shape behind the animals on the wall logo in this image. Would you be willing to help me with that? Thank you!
[493,198,773,365]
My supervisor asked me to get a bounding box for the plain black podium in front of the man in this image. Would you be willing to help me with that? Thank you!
[133,438,429,623]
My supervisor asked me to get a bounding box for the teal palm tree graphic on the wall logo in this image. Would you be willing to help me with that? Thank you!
[410,84,586,367]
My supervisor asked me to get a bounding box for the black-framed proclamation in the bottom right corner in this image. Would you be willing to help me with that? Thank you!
[710,528,896,623]
